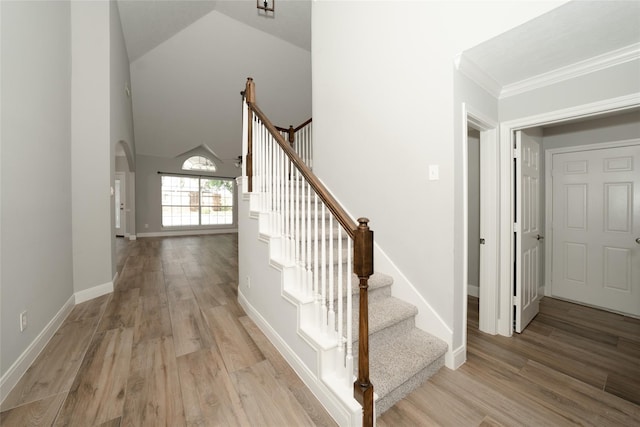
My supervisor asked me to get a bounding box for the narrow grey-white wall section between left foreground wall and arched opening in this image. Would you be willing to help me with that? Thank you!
[71,1,114,292]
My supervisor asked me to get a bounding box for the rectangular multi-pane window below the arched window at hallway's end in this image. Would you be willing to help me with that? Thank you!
[162,175,234,227]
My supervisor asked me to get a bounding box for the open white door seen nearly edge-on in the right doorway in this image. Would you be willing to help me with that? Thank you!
[514,131,542,333]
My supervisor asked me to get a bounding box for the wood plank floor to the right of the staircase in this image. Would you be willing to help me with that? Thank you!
[374,298,640,427]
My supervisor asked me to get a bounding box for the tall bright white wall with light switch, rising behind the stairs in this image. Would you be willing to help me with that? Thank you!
[312,1,561,362]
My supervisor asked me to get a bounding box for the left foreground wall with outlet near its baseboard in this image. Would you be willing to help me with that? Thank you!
[0,1,73,376]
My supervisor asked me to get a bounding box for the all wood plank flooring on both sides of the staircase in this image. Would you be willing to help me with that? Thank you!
[0,235,640,427]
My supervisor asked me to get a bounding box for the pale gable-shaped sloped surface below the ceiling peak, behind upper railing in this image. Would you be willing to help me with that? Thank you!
[131,11,311,160]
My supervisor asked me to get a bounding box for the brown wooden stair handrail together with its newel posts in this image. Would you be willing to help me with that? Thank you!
[244,78,374,427]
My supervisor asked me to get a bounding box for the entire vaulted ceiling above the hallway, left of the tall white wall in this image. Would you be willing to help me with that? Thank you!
[118,0,311,164]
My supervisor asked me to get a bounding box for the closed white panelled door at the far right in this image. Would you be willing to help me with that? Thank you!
[551,145,640,316]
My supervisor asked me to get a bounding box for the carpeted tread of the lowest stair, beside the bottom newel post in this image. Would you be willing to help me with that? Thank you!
[369,328,447,398]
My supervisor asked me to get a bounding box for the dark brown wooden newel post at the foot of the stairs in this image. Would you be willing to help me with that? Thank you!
[353,218,373,427]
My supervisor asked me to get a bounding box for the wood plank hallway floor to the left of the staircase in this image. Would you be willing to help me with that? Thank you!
[0,234,336,427]
